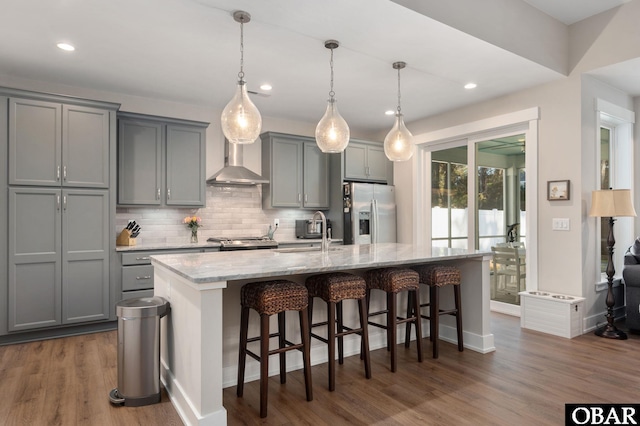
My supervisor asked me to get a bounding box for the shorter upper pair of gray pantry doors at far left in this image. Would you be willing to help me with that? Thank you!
[9,98,109,188]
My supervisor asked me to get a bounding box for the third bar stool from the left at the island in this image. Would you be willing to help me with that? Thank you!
[365,267,422,372]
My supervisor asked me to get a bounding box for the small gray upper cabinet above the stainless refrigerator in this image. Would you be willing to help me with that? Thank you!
[344,140,392,182]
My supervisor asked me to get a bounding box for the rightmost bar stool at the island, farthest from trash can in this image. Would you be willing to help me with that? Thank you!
[405,265,464,359]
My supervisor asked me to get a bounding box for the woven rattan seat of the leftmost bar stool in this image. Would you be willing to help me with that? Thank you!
[240,280,309,315]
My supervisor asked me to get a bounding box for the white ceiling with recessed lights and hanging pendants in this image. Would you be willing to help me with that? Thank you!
[0,0,625,132]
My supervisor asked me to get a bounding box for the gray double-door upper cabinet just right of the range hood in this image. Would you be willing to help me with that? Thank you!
[261,132,329,209]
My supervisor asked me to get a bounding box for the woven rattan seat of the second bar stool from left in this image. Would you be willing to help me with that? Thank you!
[305,272,367,303]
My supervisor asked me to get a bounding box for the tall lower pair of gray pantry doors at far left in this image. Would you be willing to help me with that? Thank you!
[8,187,110,332]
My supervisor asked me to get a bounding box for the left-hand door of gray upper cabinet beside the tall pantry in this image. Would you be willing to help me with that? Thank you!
[118,119,163,205]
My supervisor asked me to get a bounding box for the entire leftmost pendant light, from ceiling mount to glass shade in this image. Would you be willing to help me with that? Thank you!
[221,10,262,144]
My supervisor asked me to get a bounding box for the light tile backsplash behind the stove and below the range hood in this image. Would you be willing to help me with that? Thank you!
[114,185,320,244]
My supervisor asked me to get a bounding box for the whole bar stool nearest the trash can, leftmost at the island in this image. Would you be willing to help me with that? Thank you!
[237,280,313,417]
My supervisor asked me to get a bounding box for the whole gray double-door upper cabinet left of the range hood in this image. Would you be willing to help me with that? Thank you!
[118,113,208,207]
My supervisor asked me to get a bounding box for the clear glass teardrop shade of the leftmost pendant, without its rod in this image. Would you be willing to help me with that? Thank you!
[221,80,262,144]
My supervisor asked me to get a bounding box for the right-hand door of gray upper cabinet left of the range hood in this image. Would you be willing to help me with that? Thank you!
[166,124,207,207]
